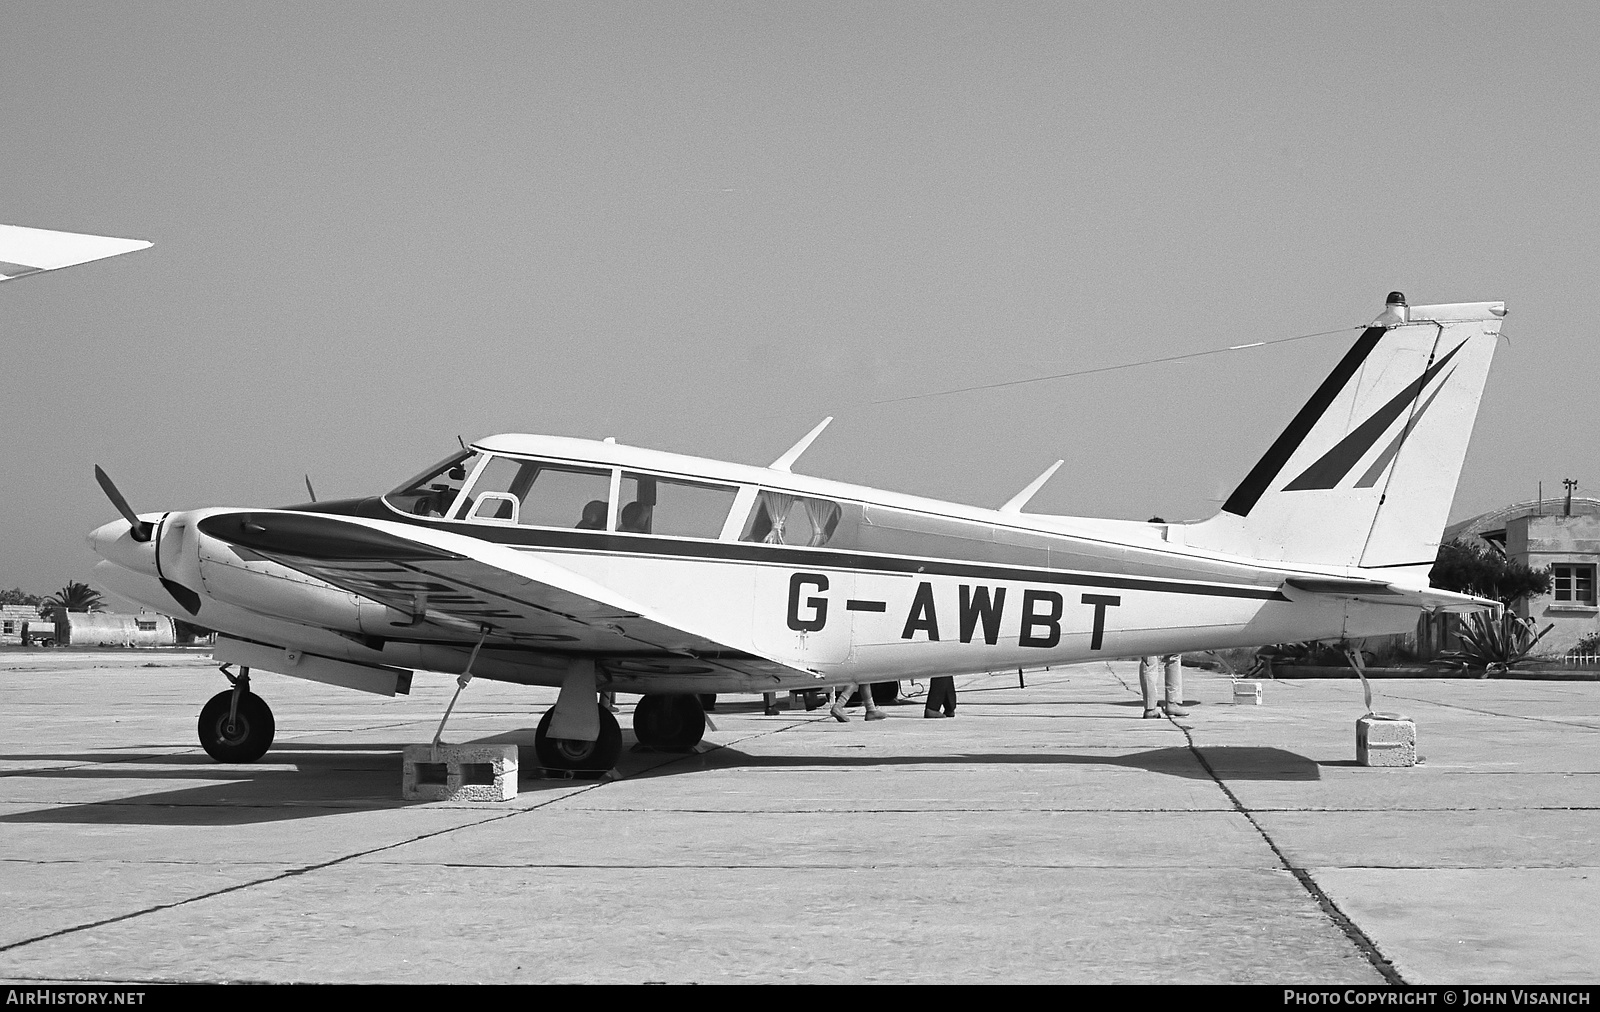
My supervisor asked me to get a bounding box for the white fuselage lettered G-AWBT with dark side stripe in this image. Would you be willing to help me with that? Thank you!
[91,436,1416,693]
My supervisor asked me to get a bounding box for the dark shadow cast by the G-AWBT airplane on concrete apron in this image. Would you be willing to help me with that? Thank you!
[0,732,1318,826]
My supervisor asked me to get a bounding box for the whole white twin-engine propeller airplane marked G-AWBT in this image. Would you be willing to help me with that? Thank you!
[90,293,1506,772]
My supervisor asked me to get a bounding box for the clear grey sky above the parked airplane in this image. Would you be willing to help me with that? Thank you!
[0,0,1600,594]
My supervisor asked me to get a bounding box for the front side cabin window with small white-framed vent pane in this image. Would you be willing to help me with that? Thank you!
[466,456,611,530]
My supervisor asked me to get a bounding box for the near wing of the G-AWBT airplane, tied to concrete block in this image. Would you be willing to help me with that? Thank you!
[200,511,819,676]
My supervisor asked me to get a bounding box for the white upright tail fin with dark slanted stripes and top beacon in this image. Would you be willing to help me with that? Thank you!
[1184,291,1506,573]
